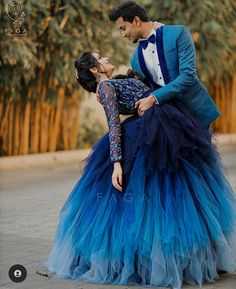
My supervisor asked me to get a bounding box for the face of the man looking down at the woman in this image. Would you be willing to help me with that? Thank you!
[116,17,141,43]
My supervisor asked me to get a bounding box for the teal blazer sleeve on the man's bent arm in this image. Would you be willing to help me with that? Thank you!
[152,26,196,104]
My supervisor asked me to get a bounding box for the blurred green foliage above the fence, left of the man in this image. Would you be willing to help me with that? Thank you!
[0,0,128,99]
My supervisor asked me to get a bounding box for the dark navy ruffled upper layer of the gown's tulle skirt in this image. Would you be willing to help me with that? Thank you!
[117,101,217,184]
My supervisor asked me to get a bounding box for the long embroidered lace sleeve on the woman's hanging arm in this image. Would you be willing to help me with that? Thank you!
[99,81,122,163]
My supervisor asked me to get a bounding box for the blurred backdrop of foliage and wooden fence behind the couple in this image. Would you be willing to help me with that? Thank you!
[0,0,236,156]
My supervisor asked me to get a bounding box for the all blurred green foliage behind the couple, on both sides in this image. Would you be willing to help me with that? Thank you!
[0,0,236,101]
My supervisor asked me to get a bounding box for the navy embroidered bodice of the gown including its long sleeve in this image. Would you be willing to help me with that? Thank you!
[98,78,150,163]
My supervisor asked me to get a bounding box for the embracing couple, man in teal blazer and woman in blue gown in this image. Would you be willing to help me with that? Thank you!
[45,1,236,289]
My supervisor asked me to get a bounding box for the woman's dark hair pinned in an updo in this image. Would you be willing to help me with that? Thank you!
[75,51,99,92]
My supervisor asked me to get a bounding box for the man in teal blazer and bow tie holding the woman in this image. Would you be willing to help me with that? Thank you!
[109,1,220,127]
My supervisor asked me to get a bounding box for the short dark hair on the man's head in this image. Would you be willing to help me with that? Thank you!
[109,1,149,23]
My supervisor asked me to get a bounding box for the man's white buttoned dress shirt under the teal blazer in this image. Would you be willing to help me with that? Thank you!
[142,29,165,86]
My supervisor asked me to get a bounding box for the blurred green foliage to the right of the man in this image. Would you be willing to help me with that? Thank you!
[140,0,236,84]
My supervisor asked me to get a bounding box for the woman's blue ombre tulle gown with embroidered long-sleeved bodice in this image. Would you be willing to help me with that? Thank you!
[44,79,236,288]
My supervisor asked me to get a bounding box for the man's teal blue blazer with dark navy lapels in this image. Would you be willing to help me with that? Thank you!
[130,25,220,127]
